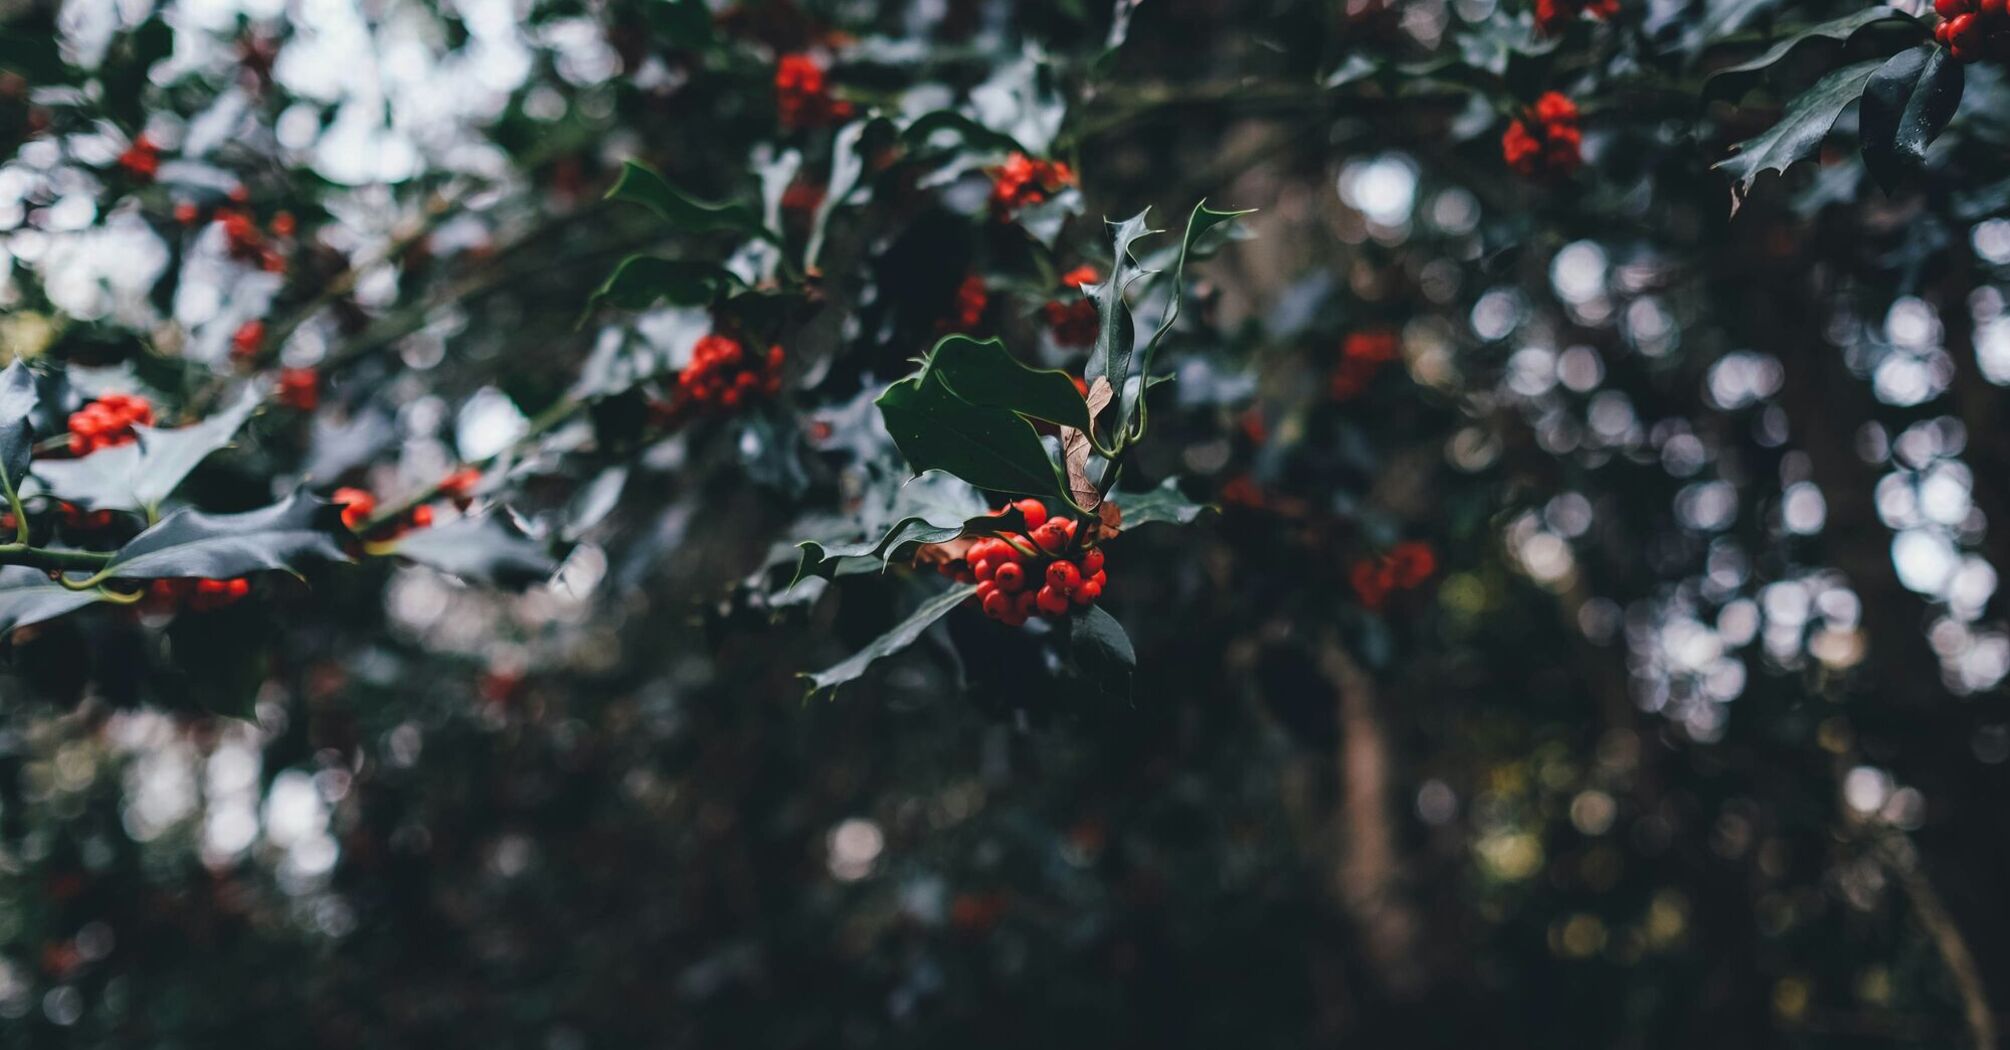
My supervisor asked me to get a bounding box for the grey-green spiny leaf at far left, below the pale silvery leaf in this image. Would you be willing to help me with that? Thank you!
[105,493,350,579]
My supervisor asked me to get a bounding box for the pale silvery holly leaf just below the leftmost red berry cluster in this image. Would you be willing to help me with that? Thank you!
[34,386,263,511]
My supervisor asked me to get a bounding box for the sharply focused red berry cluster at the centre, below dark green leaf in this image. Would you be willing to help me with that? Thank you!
[939,499,1110,628]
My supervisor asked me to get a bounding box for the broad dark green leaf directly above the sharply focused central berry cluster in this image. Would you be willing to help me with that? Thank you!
[878,372,1067,503]
